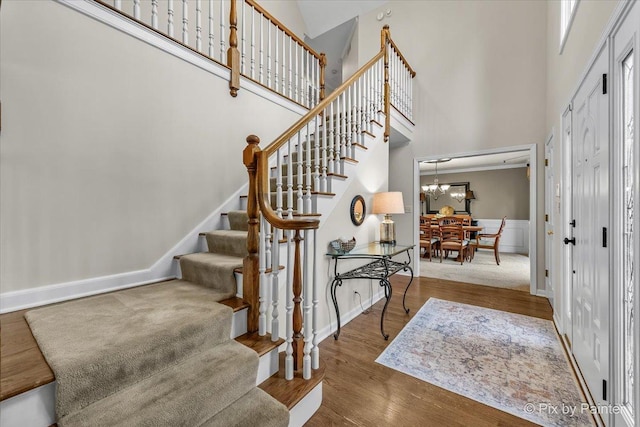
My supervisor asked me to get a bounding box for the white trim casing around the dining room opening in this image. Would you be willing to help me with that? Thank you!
[413,144,546,296]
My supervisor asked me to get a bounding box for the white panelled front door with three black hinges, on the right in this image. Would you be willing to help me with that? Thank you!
[572,45,610,412]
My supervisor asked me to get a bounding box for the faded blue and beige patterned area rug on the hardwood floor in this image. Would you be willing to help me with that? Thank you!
[376,298,592,426]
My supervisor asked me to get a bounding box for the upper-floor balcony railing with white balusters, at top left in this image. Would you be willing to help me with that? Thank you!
[99,0,326,108]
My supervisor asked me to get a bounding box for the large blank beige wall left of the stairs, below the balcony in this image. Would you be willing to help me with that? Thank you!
[0,1,310,293]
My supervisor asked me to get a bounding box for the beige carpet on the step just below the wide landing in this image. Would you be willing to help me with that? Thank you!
[62,340,258,426]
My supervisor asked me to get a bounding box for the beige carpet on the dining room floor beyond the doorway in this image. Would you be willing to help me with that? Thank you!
[420,249,530,292]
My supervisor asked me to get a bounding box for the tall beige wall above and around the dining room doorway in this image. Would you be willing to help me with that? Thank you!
[358,0,547,286]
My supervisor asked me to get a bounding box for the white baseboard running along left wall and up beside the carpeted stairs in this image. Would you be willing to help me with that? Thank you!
[0,184,248,313]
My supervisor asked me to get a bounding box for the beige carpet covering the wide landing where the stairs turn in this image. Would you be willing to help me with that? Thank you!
[26,280,233,416]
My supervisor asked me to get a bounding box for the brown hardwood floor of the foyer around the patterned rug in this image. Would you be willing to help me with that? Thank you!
[306,275,552,427]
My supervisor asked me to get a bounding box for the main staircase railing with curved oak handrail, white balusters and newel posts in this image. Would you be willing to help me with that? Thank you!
[243,26,415,379]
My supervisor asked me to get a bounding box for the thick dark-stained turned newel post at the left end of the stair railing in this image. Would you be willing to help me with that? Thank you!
[242,135,260,332]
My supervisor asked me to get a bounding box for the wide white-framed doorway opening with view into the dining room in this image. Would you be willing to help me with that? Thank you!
[414,145,538,295]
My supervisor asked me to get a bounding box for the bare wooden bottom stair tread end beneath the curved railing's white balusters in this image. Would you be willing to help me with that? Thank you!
[258,352,325,410]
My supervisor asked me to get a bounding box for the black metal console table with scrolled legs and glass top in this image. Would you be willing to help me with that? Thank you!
[327,242,414,340]
